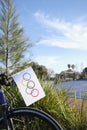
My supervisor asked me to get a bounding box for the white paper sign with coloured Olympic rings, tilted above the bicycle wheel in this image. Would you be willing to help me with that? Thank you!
[12,67,45,106]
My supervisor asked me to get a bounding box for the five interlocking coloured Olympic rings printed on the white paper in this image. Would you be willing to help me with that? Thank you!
[21,73,39,97]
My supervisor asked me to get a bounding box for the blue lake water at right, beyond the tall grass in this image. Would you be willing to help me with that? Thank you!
[57,80,87,99]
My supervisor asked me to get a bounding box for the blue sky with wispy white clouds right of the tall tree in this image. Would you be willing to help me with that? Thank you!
[15,0,87,73]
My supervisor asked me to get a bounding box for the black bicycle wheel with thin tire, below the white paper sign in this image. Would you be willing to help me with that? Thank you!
[0,107,63,130]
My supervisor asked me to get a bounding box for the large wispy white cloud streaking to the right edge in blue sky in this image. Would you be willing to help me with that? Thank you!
[34,12,87,49]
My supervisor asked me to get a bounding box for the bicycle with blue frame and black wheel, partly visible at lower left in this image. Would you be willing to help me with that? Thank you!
[0,73,62,130]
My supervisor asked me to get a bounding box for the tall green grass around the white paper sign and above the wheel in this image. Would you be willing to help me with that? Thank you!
[4,82,87,130]
